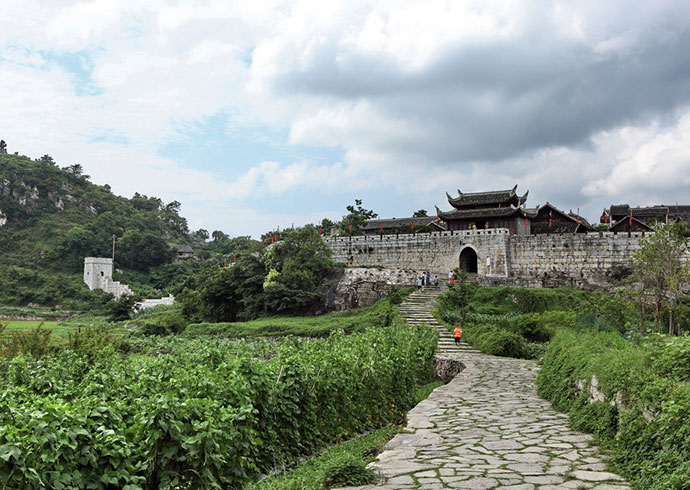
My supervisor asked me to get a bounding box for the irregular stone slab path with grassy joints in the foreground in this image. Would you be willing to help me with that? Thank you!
[336,352,630,490]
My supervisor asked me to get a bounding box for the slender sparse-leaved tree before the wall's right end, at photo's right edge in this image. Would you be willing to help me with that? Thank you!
[631,224,690,334]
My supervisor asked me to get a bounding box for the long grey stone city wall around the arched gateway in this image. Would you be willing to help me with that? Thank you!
[326,229,643,289]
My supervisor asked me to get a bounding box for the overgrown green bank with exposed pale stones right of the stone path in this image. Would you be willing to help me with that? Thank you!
[538,331,690,490]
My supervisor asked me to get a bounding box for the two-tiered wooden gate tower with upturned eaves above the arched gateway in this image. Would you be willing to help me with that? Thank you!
[436,185,534,235]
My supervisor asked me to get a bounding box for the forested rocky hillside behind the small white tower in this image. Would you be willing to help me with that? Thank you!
[0,153,209,308]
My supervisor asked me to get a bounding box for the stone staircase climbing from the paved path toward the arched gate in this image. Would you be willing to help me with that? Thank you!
[398,285,479,354]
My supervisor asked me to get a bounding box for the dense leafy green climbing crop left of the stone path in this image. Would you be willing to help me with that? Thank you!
[0,325,436,490]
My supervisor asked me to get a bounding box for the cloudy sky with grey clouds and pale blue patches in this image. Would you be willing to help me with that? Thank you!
[0,0,690,237]
